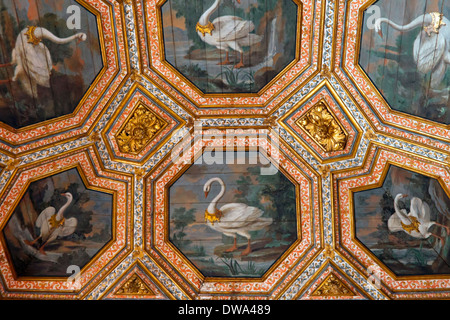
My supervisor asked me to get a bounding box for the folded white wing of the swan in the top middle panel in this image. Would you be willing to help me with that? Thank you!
[213,16,255,41]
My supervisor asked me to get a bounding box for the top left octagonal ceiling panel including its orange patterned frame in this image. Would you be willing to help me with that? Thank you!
[0,0,127,154]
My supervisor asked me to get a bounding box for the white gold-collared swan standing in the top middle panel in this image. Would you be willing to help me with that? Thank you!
[196,0,262,68]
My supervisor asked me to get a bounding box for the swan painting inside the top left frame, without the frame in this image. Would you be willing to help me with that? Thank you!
[0,0,103,128]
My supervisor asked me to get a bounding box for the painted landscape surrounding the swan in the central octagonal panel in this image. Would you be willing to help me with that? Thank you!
[169,152,297,277]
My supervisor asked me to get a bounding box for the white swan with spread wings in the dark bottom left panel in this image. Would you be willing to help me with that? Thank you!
[24,192,78,254]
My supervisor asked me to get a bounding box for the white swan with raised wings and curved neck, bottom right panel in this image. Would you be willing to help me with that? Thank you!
[388,193,450,244]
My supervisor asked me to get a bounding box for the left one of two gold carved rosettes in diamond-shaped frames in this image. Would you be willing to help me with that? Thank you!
[116,105,167,153]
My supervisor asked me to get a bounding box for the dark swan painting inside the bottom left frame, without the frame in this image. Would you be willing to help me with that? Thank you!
[3,169,113,276]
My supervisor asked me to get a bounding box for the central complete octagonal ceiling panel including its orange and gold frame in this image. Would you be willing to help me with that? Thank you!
[145,130,320,295]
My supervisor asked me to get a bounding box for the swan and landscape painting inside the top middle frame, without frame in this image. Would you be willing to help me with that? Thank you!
[161,0,299,93]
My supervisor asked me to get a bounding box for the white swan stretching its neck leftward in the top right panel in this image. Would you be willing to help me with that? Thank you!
[374,12,450,92]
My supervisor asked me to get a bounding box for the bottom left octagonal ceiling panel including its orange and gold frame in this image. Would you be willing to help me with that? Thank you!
[0,148,131,298]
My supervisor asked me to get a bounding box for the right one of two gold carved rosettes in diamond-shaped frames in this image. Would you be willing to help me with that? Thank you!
[297,103,348,152]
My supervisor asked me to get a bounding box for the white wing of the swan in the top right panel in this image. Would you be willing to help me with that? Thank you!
[414,32,446,73]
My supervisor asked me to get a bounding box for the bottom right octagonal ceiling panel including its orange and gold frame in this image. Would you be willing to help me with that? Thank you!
[334,148,450,297]
